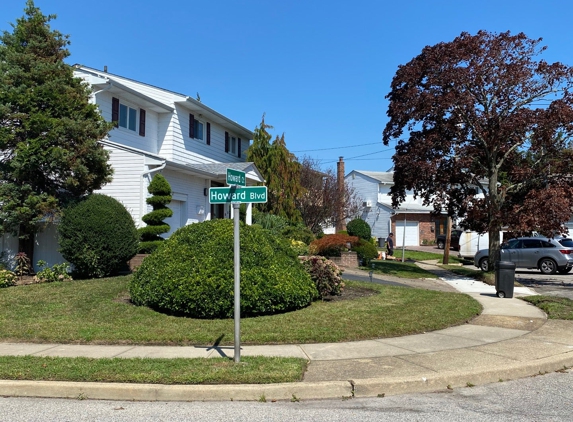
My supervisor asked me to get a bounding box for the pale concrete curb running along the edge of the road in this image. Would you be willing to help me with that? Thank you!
[0,351,573,401]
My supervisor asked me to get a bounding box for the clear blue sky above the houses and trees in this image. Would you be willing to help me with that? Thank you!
[0,0,573,173]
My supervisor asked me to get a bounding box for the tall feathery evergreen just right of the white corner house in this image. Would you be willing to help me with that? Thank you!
[247,115,301,222]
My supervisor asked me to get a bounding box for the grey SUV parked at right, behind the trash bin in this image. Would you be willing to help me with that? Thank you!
[474,237,573,274]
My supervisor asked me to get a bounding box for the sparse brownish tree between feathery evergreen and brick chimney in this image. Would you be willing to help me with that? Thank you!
[295,157,359,234]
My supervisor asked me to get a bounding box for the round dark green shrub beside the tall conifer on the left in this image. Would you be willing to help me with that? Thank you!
[58,194,139,278]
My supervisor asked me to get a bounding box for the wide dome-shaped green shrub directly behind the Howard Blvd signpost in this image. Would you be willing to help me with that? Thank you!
[129,219,318,318]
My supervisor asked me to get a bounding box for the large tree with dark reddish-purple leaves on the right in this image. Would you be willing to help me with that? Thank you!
[383,31,573,268]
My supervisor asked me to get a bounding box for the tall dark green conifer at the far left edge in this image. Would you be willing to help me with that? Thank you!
[0,0,112,259]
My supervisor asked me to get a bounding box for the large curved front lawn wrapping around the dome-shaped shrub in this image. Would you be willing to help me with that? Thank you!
[0,276,481,346]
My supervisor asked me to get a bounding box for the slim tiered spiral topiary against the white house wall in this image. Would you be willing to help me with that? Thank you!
[138,173,173,253]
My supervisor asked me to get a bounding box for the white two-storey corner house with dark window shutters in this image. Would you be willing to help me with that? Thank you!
[0,65,264,265]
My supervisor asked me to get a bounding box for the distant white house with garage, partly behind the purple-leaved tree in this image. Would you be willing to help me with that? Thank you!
[345,170,438,247]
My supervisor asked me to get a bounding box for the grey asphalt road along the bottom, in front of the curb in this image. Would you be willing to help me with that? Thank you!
[0,371,573,422]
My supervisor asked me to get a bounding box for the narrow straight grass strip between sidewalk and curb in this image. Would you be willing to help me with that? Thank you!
[0,356,308,384]
